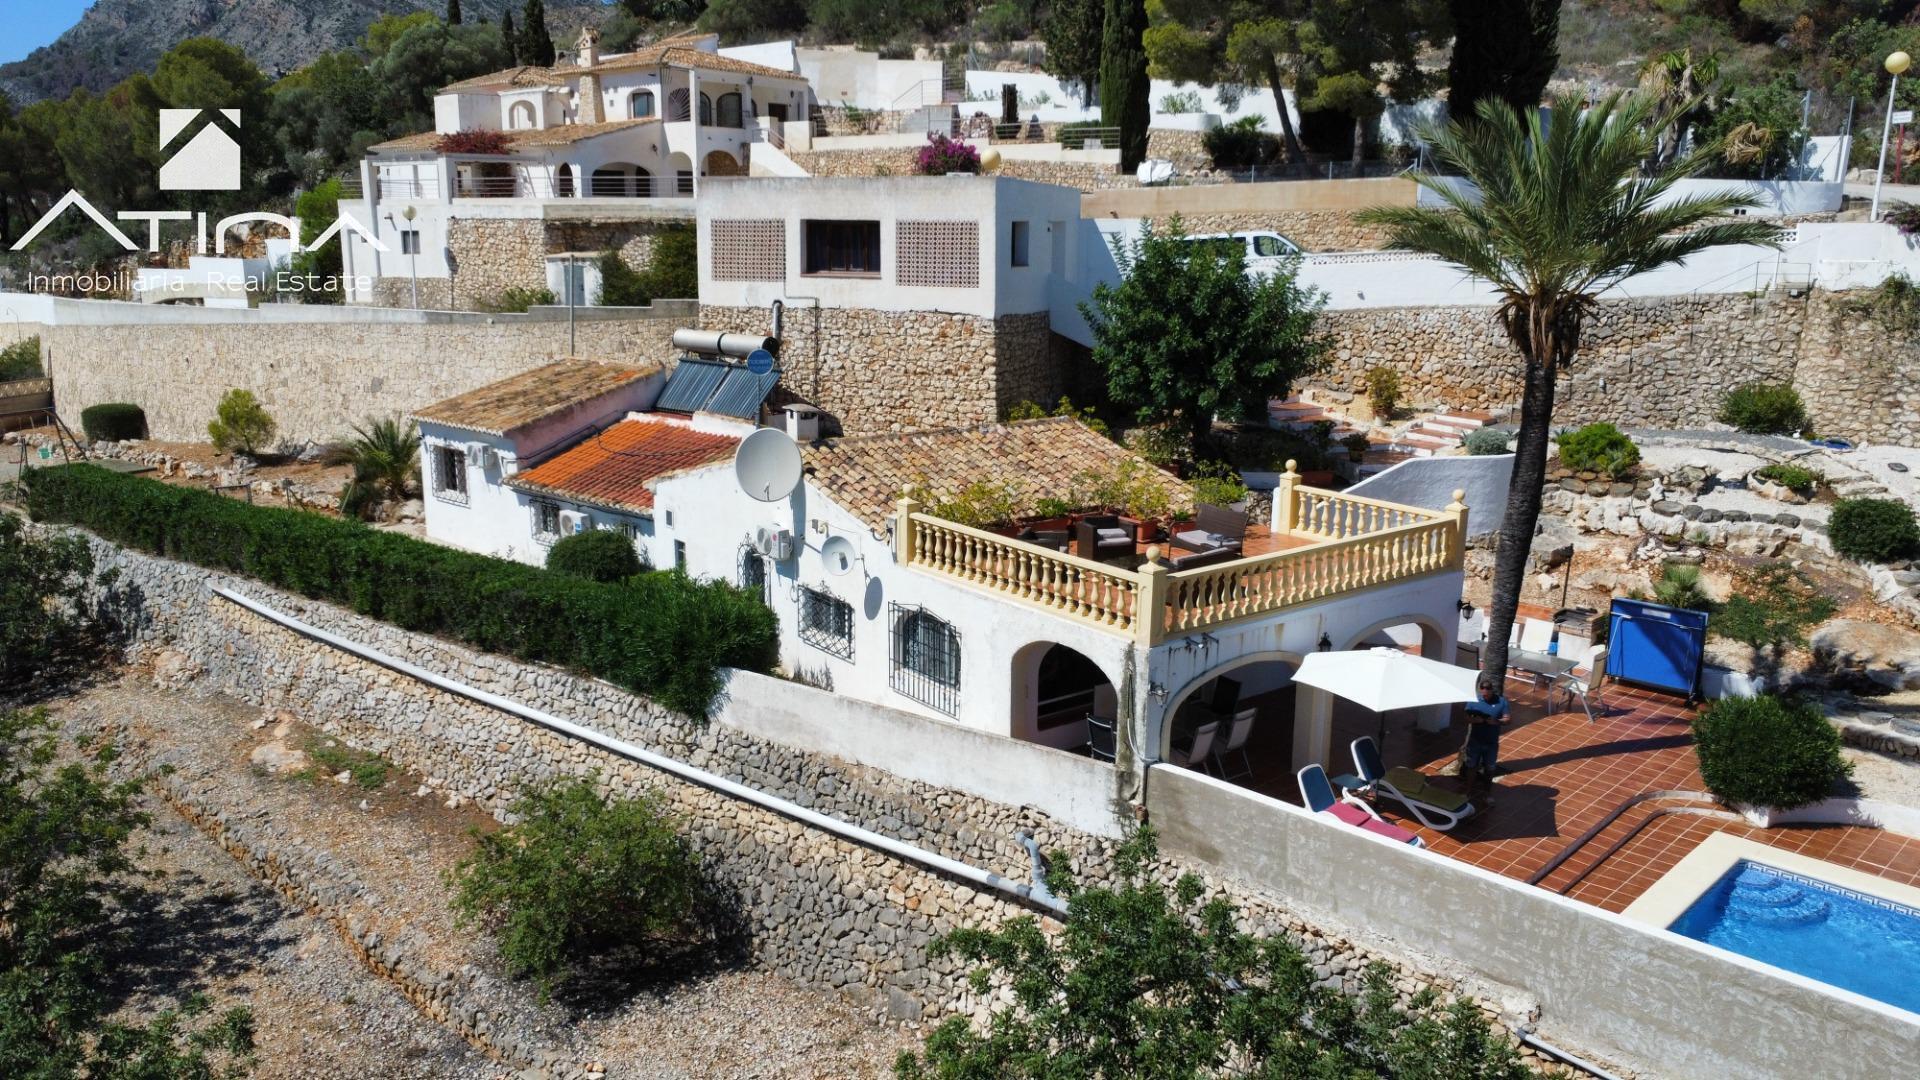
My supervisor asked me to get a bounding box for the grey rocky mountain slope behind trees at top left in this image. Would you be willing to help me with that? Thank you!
[0,0,599,102]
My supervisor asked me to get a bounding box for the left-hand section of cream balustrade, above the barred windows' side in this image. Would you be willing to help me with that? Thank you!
[895,502,1140,632]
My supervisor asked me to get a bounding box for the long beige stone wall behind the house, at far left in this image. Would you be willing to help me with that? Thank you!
[42,305,693,442]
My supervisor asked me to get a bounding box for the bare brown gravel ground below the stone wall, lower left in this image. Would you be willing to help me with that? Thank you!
[43,673,918,1080]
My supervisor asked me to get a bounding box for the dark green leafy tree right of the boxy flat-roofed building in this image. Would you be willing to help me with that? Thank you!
[1081,219,1327,448]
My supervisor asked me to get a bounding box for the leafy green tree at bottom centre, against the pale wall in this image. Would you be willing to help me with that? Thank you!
[895,828,1528,1080]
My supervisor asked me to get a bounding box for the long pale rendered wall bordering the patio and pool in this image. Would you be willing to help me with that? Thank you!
[1146,765,1920,1080]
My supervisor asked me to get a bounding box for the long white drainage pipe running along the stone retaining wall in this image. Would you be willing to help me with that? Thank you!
[207,584,1068,917]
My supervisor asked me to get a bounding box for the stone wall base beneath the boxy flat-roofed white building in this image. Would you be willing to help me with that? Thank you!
[701,306,1066,434]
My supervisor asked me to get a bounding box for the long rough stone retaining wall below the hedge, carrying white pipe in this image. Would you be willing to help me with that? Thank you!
[67,532,1566,1059]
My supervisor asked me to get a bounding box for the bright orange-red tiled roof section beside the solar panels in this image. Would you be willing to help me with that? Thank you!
[507,419,739,515]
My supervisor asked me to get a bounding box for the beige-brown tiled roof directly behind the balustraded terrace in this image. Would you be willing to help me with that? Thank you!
[791,417,1192,528]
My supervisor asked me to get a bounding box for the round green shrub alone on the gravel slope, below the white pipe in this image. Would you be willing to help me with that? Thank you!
[449,780,701,997]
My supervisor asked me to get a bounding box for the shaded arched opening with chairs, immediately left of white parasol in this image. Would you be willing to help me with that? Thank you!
[1160,651,1313,799]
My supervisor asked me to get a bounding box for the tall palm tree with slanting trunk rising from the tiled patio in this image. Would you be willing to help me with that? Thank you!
[1359,94,1780,684]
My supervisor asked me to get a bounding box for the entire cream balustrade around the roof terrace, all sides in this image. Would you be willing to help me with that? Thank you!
[895,469,1467,648]
